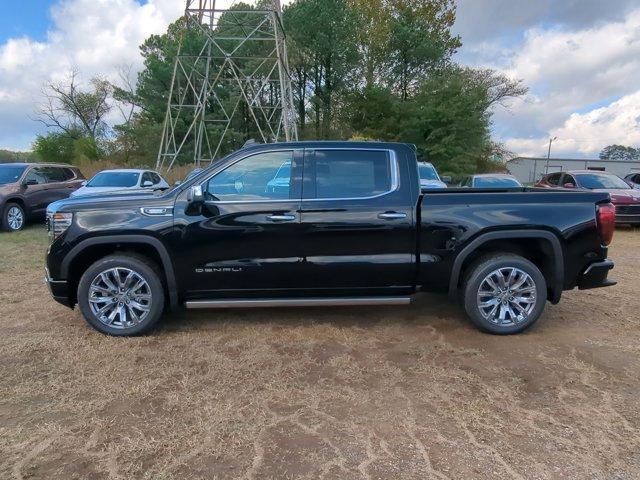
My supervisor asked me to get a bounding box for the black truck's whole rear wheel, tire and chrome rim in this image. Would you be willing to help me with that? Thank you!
[463,254,547,335]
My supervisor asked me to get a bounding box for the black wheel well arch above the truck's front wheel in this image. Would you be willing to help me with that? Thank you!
[67,243,169,304]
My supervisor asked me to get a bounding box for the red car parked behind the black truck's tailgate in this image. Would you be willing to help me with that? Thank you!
[535,170,640,225]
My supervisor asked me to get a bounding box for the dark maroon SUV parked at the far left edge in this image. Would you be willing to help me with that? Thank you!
[0,163,85,232]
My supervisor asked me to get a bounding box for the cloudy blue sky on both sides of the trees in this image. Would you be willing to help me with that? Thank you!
[0,0,640,157]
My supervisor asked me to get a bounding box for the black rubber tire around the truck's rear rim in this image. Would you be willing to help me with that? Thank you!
[464,255,547,335]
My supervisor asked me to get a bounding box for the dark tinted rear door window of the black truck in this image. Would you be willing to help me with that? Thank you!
[304,149,395,199]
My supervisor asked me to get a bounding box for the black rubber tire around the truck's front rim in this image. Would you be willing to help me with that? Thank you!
[78,255,164,337]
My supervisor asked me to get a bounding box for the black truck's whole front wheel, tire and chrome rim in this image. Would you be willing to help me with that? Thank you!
[78,254,164,337]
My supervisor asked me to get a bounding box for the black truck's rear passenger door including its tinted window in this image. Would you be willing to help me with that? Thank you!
[300,149,416,294]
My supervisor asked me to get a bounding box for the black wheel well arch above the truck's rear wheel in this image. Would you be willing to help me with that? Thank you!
[458,238,556,298]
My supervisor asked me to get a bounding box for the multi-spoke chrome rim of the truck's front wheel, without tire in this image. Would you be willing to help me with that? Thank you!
[89,267,152,329]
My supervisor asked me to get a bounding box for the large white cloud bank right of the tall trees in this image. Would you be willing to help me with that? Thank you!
[463,8,640,156]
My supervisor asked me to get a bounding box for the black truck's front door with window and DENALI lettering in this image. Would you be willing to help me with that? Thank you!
[175,150,302,298]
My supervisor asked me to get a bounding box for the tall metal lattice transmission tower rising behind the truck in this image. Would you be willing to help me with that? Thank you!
[156,0,298,170]
